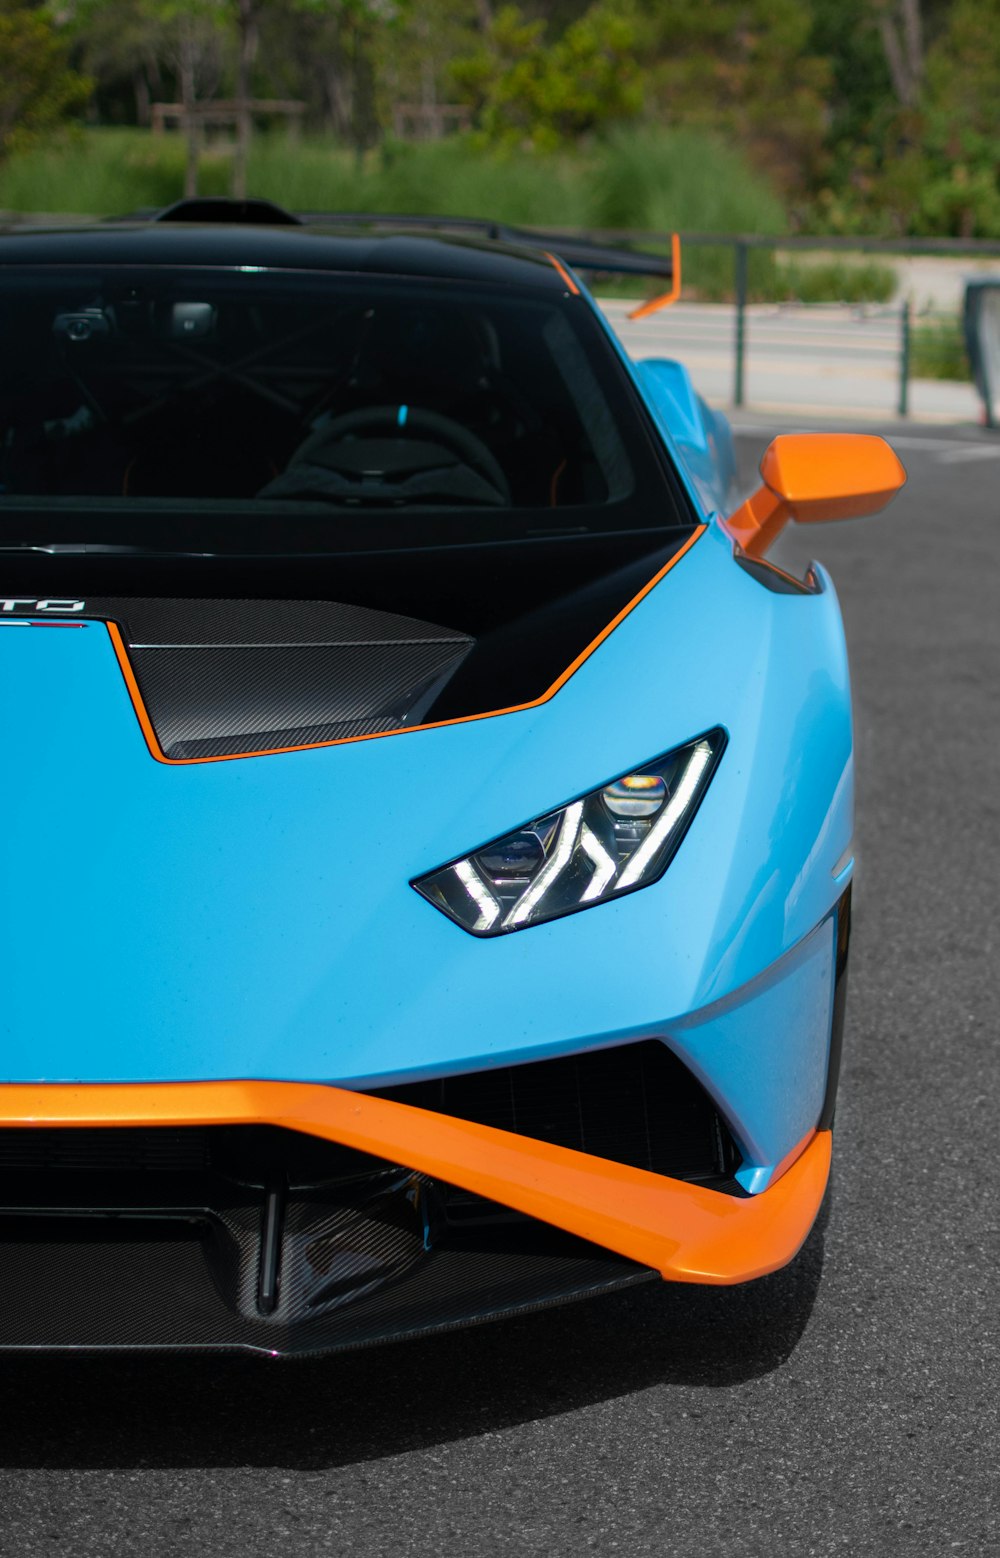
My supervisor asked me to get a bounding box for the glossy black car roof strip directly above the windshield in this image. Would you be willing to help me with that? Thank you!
[0,220,567,294]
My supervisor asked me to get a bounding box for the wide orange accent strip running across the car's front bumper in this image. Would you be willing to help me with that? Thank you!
[0,1081,830,1284]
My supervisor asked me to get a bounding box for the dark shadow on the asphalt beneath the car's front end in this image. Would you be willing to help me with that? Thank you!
[0,1197,830,1471]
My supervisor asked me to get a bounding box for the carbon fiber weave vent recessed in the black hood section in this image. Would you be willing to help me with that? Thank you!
[87,598,475,759]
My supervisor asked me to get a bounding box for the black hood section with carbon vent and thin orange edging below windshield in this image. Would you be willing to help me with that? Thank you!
[3,531,690,760]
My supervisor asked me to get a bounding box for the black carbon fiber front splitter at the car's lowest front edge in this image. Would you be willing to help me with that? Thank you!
[0,1218,654,1357]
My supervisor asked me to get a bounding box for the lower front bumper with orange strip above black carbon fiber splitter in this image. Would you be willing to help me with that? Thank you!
[0,1081,830,1352]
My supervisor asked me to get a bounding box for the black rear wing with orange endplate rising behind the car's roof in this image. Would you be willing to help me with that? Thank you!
[146,196,681,319]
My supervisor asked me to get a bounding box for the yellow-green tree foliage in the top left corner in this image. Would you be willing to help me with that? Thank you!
[0,3,92,157]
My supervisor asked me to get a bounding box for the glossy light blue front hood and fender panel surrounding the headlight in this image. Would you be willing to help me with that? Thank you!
[0,511,852,1190]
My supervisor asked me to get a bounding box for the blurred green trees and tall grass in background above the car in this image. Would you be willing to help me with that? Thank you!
[0,0,1000,238]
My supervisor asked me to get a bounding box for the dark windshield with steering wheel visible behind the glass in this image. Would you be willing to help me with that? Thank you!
[0,266,687,542]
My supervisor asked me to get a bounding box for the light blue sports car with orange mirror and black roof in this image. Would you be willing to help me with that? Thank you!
[0,201,903,1354]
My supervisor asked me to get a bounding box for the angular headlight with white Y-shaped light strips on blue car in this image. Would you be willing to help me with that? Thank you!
[413,731,726,936]
